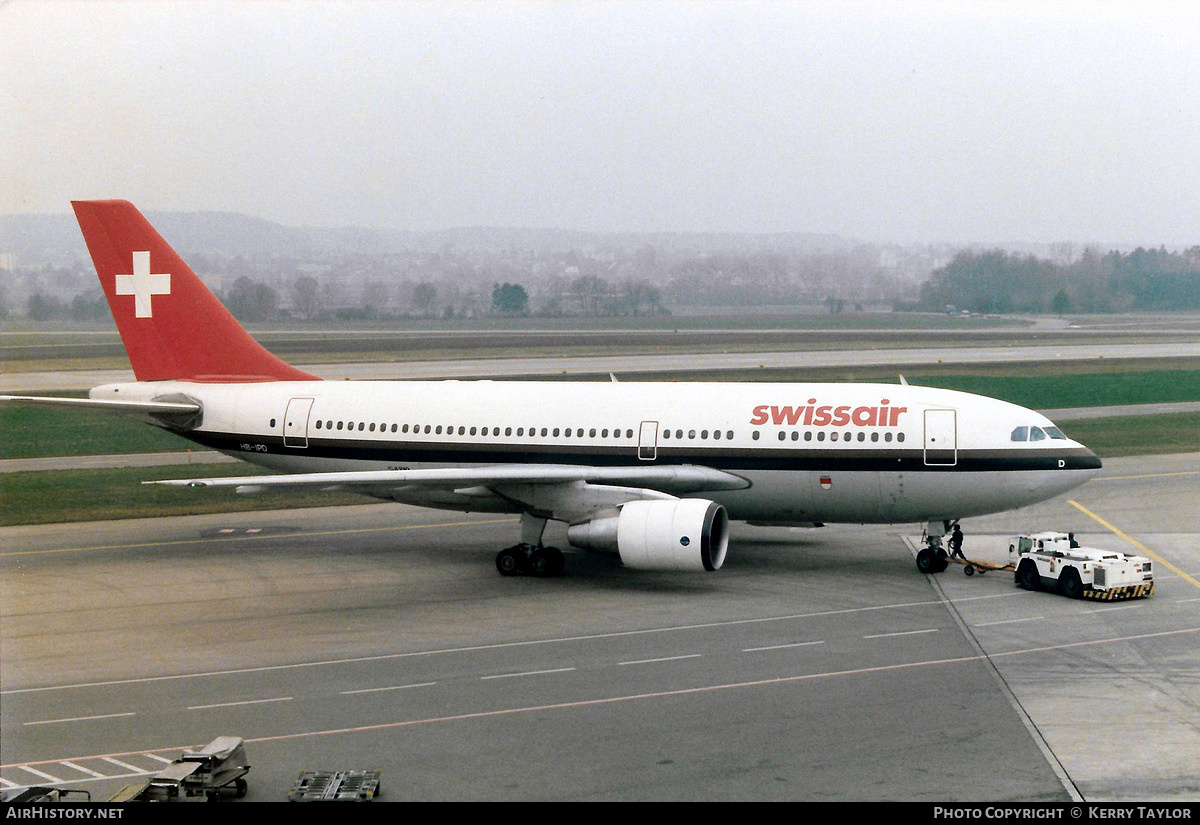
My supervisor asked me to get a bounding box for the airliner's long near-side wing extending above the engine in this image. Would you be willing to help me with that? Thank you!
[150,464,750,520]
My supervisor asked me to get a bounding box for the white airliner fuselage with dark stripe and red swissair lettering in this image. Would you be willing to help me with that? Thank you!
[91,381,1100,524]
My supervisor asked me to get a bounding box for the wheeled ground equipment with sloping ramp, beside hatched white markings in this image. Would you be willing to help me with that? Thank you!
[109,736,250,802]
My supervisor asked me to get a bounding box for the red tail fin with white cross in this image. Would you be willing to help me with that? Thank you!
[71,200,316,381]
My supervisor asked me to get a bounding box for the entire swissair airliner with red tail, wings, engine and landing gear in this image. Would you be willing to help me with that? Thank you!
[0,200,1100,577]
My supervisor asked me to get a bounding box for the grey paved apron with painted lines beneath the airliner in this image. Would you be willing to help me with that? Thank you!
[0,454,1200,802]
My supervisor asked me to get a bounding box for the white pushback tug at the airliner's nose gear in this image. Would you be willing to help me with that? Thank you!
[1008,532,1154,601]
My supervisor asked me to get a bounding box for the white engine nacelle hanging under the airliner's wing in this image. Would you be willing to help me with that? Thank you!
[566,499,730,571]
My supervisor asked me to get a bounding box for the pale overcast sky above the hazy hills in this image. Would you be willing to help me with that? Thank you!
[0,0,1200,246]
